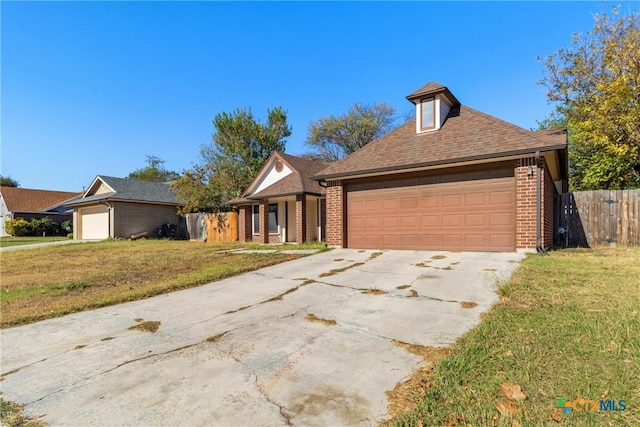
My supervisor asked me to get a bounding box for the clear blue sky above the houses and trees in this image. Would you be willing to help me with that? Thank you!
[0,1,640,191]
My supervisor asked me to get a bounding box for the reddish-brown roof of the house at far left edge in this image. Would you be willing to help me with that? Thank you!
[0,187,82,212]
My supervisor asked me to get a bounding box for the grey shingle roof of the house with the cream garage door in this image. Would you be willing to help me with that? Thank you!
[67,175,178,206]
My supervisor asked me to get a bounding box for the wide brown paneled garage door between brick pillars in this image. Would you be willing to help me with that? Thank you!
[346,168,516,251]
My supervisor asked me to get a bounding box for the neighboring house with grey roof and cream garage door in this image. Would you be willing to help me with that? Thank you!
[67,176,179,240]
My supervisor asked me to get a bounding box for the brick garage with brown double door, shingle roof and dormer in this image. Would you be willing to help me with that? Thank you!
[314,83,567,251]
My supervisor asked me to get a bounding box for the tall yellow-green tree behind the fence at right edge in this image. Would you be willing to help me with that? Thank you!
[540,8,640,190]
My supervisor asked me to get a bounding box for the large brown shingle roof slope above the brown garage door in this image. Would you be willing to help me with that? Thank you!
[314,105,567,180]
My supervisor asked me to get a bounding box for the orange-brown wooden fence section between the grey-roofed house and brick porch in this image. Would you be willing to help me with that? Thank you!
[185,212,238,243]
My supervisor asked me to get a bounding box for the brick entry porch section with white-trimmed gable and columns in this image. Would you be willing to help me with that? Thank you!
[229,151,327,243]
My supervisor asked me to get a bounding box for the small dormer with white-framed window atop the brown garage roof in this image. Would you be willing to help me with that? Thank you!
[407,82,460,133]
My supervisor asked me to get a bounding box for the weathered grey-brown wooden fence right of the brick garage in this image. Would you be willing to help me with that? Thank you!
[556,190,640,247]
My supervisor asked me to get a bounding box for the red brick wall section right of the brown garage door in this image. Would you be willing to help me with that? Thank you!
[515,157,555,249]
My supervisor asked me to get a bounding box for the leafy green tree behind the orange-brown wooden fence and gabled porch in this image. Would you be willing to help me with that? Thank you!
[172,107,291,213]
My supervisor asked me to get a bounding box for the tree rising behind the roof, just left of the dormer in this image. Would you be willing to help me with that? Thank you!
[305,102,396,162]
